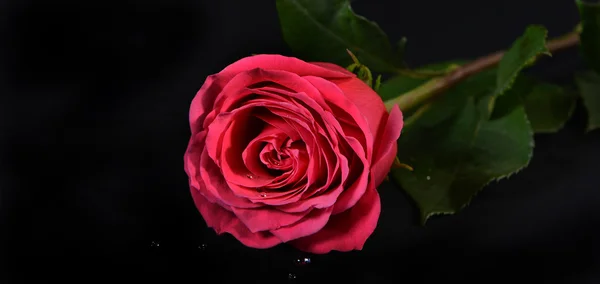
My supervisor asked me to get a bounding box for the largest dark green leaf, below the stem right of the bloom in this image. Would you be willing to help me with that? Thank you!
[391,66,533,223]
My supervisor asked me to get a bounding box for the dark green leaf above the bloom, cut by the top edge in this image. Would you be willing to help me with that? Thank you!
[277,0,402,73]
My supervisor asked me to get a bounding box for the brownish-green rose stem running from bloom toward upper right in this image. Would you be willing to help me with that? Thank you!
[385,28,580,111]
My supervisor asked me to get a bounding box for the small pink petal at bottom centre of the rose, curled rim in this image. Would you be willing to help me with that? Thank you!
[271,207,332,243]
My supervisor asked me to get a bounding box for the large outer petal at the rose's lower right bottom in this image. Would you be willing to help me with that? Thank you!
[290,184,381,254]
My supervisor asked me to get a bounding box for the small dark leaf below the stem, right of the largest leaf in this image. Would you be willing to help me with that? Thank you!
[492,75,577,133]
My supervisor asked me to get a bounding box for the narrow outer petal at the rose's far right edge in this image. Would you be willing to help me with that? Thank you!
[371,105,404,186]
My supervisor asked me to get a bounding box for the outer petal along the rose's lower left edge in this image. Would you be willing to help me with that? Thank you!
[191,184,281,248]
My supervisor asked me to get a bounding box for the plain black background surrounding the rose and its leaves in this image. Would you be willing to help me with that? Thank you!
[0,0,600,283]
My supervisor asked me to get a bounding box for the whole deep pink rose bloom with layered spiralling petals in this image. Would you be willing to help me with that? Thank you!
[184,55,403,253]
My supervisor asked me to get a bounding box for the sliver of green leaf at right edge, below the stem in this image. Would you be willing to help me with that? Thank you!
[575,72,600,131]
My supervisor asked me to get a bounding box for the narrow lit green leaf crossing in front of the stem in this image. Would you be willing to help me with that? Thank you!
[494,25,550,96]
